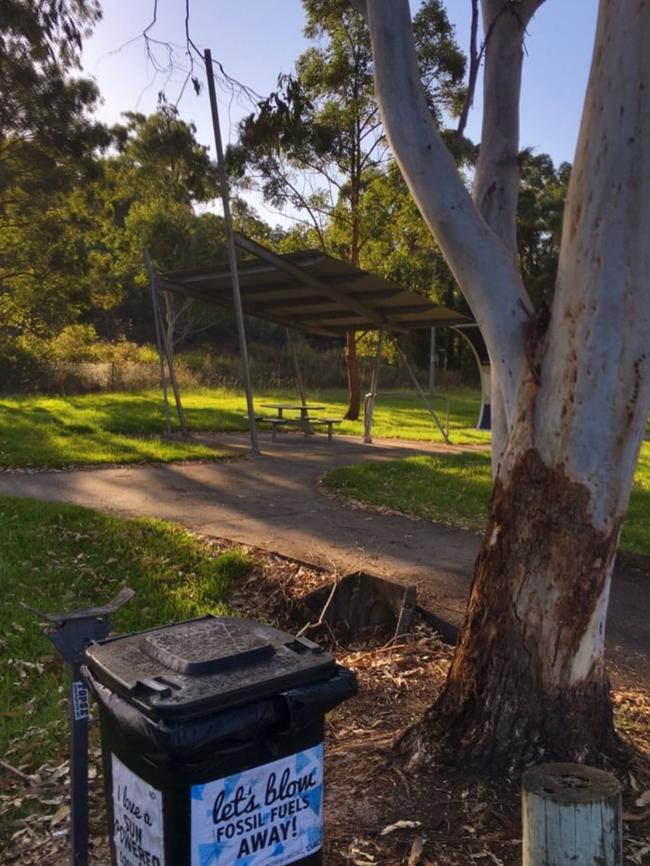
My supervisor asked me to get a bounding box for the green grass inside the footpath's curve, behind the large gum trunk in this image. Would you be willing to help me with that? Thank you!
[322,442,650,556]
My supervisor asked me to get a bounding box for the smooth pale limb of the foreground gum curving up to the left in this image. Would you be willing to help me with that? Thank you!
[368,0,531,424]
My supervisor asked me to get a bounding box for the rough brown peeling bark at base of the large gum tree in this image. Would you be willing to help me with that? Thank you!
[403,450,618,770]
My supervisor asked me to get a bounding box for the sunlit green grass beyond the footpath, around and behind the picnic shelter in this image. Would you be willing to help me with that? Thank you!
[0,389,489,468]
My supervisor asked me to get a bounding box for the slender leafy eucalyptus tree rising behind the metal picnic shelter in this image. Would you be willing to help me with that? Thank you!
[230,0,465,418]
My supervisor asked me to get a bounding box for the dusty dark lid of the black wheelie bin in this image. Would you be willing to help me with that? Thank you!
[86,616,336,721]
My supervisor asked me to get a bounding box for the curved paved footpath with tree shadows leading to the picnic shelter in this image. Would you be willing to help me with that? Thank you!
[0,434,650,690]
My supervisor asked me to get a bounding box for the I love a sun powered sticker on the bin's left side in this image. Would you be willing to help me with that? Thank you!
[111,755,165,866]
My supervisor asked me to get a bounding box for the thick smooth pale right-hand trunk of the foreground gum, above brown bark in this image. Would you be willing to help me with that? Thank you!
[535,0,650,530]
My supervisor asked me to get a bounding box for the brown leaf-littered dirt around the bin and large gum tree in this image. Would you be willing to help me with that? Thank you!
[0,543,650,866]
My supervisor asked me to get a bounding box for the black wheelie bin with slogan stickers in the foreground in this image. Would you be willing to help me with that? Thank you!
[83,616,356,866]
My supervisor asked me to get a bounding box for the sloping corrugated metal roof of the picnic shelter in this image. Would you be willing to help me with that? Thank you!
[158,233,470,336]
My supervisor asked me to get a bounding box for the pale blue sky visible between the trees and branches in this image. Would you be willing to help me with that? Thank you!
[83,0,597,222]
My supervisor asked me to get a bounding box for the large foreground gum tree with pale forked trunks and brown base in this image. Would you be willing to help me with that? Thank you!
[354,0,650,768]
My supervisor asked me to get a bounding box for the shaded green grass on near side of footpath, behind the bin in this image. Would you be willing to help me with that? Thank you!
[0,497,253,767]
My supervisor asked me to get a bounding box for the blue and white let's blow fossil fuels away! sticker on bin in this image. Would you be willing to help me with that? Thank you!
[192,743,323,866]
